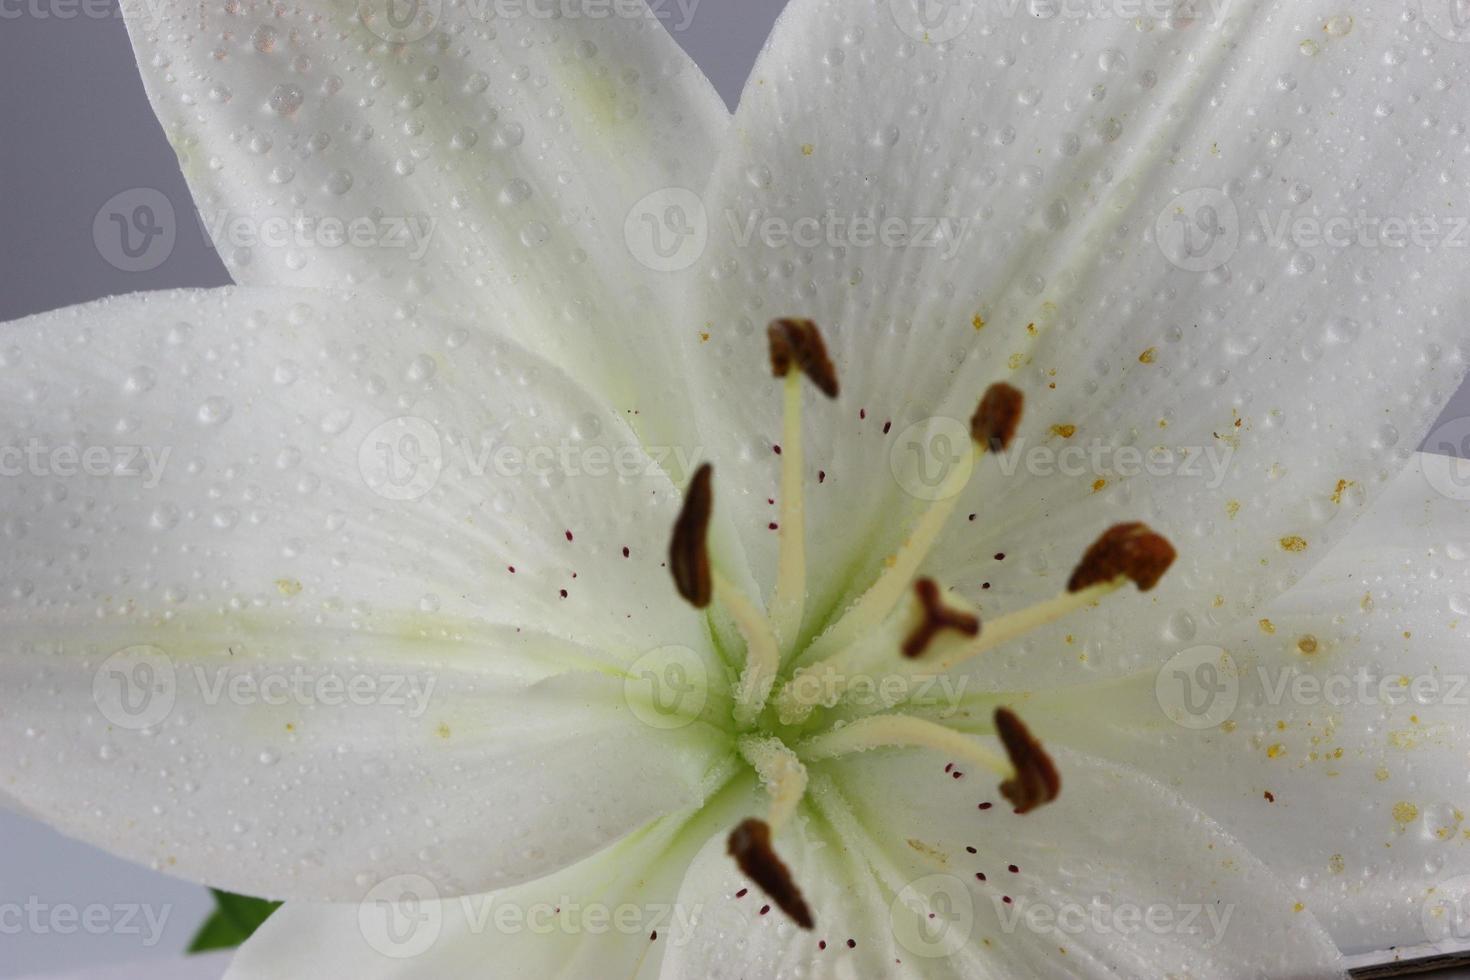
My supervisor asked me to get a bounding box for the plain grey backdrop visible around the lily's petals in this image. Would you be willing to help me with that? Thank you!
[0,0,1470,977]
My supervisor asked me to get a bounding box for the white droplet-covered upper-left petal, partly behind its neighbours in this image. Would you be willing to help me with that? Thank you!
[128,0,729,426]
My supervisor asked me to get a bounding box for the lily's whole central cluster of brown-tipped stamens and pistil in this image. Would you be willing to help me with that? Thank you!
[669,319,1175,929]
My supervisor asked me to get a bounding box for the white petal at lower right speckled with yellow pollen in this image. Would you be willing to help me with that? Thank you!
[1005,455,1470,951]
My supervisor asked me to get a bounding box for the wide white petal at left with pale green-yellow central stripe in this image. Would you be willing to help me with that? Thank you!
[0,288,723,898]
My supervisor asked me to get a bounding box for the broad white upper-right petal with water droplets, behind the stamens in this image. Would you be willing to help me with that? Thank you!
[689,0,1466,667]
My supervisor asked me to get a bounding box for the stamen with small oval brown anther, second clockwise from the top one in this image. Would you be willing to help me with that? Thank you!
[782,383,1023,675]
